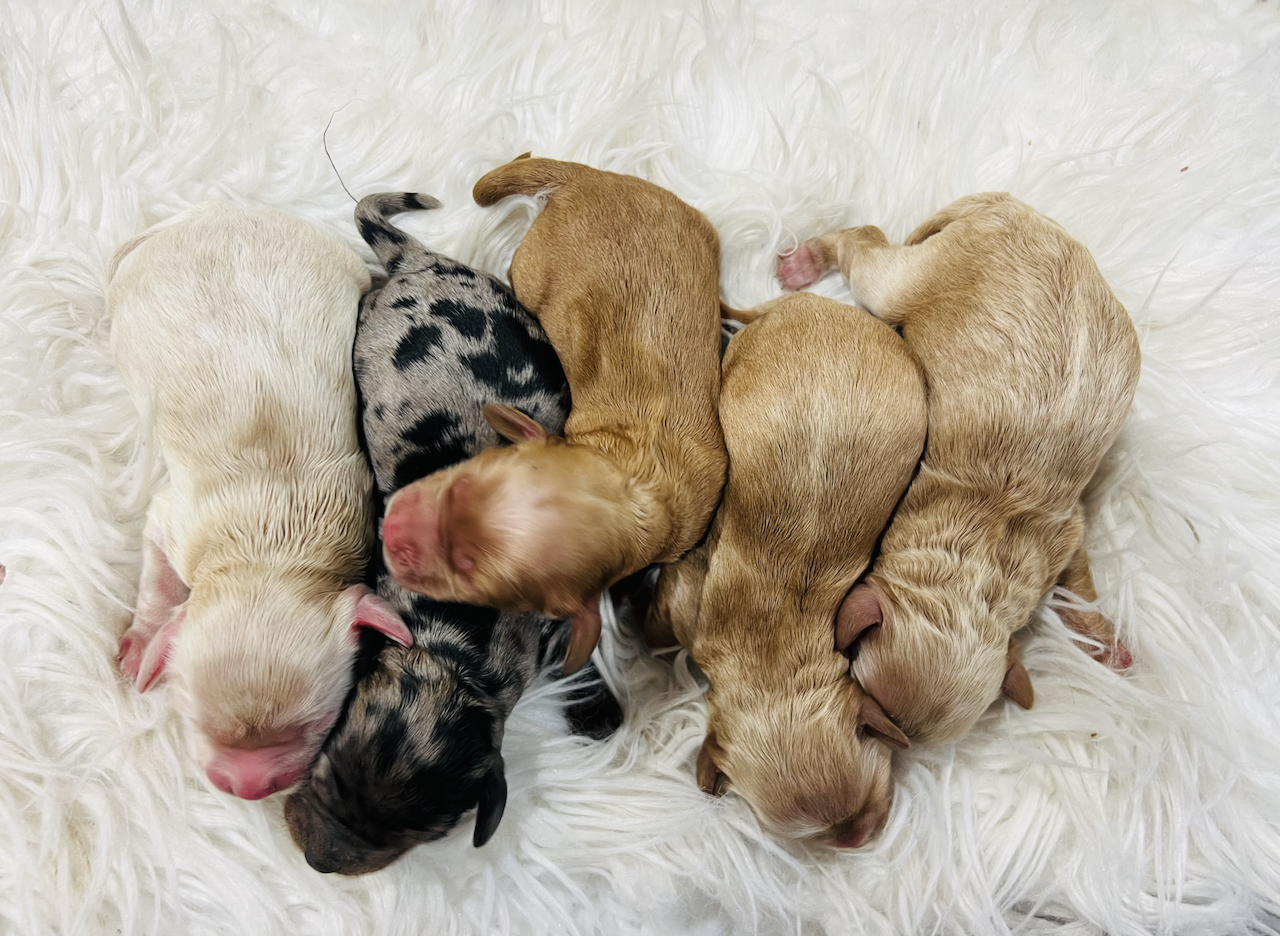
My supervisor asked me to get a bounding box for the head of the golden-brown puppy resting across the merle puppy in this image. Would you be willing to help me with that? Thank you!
[383,405,637,672]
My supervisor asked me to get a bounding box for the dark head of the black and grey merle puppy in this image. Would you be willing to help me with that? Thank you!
[284,647,507,875]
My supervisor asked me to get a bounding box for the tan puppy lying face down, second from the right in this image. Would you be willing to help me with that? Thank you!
[645,293,927,846]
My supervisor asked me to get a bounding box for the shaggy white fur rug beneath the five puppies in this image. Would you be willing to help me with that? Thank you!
[0,0,1280,936]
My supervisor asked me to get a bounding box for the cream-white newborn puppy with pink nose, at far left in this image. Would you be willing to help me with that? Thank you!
[106,201,412,799]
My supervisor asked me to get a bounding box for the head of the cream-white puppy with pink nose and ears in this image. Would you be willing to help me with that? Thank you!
[167,576,412,799]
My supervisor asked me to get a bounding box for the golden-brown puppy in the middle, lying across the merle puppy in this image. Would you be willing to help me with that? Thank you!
[383,159,726,672]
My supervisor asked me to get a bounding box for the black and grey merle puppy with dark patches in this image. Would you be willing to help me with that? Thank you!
[284,193,622,875]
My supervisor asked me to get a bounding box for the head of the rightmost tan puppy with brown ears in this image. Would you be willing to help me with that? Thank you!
[836,583,1034,741]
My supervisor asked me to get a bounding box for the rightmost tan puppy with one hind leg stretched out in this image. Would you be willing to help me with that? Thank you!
[778,193,1139,739]
